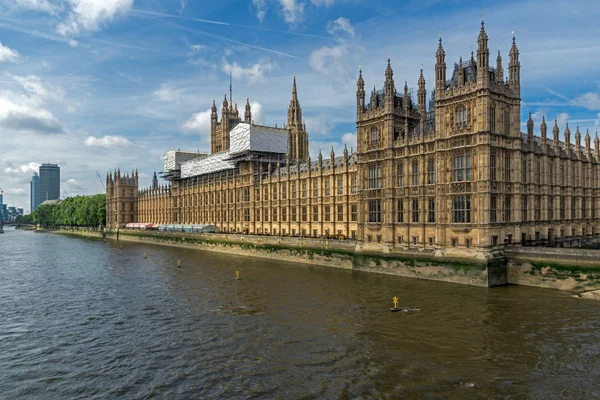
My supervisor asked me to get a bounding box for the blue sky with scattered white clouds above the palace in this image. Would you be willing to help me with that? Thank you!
[0,0,600,210]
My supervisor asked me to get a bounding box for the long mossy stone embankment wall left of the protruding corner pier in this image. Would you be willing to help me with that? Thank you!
[107,230,496,287]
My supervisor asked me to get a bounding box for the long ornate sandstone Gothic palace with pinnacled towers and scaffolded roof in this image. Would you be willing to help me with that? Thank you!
[106,22,600,256]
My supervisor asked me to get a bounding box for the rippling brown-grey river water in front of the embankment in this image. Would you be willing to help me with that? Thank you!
[0,229,600,399]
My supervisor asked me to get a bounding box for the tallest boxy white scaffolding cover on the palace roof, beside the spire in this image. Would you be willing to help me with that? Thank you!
[229,123,288,156]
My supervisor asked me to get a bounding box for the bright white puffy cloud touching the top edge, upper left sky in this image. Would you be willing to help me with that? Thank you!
[57,0,134,36]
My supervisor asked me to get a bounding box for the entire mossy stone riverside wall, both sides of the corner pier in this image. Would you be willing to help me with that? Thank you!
[45,228,600,293]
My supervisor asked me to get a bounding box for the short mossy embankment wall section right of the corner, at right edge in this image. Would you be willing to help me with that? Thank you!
[506,247,600,297]
